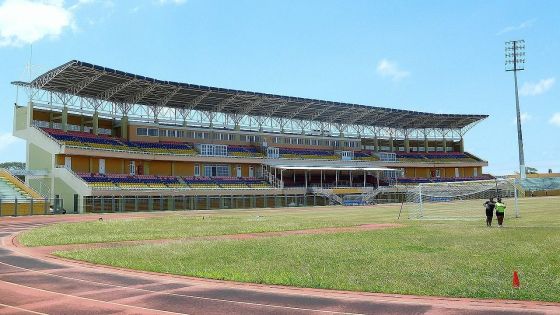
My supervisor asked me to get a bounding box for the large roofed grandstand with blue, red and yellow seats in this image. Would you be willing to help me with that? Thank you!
[12,60,488,212]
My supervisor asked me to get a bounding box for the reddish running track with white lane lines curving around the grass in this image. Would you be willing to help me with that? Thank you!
[0,214,560,315]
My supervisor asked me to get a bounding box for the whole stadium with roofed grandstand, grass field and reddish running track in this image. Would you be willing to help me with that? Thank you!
[0,60,560,314]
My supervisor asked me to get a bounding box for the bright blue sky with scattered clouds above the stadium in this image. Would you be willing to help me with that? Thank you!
[0,0,560,175]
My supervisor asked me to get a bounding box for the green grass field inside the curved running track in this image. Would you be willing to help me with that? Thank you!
[21,197,560,302]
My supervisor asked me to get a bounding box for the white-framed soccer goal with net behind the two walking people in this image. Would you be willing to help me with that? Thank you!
[406,178,519,220]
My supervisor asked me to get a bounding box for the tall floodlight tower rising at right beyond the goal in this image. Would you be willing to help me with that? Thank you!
[506,40,527,178]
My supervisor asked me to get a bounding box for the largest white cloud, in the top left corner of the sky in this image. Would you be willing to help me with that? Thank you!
[0,0,73,47]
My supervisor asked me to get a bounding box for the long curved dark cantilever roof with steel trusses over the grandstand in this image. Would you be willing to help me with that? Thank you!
[13,60,488,129]
